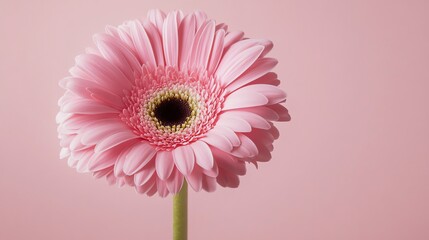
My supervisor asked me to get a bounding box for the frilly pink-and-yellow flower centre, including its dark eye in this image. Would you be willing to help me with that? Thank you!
[120,66,224,150]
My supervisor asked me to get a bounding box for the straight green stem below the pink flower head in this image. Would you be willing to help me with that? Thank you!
[173,181,188,240]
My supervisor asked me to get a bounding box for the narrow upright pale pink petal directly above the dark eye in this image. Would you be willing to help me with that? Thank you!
[162,12,179,66]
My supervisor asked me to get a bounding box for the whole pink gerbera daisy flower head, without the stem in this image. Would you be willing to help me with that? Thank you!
[57,10,290,197]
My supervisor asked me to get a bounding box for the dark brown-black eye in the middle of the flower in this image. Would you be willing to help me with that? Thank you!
[153,97,192,126]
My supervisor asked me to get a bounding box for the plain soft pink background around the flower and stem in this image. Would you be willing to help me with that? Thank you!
[0,0,429,240]
